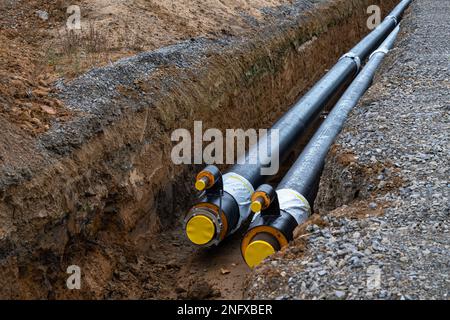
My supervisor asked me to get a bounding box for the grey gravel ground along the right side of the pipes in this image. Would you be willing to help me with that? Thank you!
[249,0,450,299]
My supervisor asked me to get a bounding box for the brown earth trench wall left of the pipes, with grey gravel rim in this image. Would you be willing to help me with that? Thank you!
[0,0,397,298]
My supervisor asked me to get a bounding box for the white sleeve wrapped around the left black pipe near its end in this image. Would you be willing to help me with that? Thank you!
[223,172,255,233]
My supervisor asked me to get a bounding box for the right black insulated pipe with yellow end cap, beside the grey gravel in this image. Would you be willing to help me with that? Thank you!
[241,27,399,267]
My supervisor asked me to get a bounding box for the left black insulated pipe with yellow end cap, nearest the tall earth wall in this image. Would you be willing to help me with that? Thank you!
[185,0,412,246]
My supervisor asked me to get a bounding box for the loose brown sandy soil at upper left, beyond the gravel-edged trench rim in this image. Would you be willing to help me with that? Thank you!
[0,0,291,135]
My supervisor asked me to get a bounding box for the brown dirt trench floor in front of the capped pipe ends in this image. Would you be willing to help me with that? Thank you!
[104,228,250,300]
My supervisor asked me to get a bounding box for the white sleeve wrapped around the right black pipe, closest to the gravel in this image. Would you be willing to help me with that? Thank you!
[277,189,311,225]
